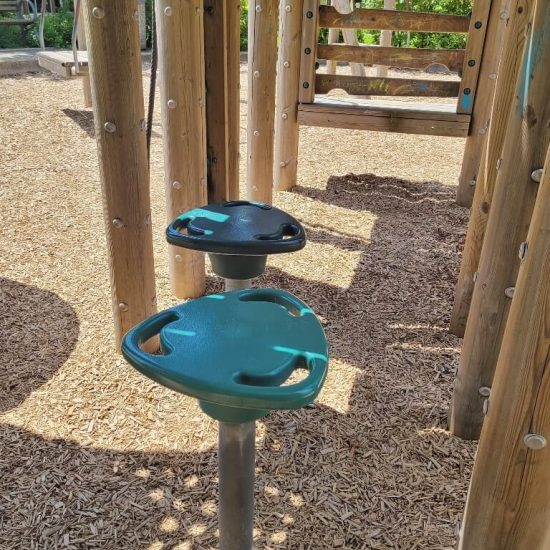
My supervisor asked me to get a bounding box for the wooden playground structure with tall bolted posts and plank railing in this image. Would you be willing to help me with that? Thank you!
[30,0,550,550]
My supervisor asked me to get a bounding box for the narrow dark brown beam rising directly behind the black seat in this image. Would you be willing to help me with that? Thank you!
[204,0,229,203]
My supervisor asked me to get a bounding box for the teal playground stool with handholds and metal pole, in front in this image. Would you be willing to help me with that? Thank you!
[122,289,328,550]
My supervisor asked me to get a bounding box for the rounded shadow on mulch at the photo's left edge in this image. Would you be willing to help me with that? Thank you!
[0,277,79,413]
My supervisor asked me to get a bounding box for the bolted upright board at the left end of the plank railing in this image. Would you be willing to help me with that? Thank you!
[299,0,319,103]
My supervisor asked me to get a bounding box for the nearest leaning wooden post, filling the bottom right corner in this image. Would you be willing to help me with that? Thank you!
[459,147,550,550]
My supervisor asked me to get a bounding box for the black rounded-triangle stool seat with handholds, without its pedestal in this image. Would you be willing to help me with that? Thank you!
[166,201,306,256]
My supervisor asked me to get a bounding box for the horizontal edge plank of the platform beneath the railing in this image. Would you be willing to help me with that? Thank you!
[298,103,469,137]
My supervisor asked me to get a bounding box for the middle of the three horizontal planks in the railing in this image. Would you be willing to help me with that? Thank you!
[317,44,464,71]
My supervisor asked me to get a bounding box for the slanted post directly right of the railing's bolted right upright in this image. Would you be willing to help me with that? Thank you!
[456,0,521,206]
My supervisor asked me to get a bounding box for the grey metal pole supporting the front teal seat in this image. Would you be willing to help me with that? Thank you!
[218,422,256,550]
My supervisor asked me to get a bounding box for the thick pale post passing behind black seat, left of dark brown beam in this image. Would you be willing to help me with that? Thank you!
[156,0,206,298]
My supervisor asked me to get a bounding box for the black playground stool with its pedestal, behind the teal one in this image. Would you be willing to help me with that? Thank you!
[166,201,306,290]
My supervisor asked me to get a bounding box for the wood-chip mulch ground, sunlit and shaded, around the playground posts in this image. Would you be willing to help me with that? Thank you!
[0,61,475,550]
